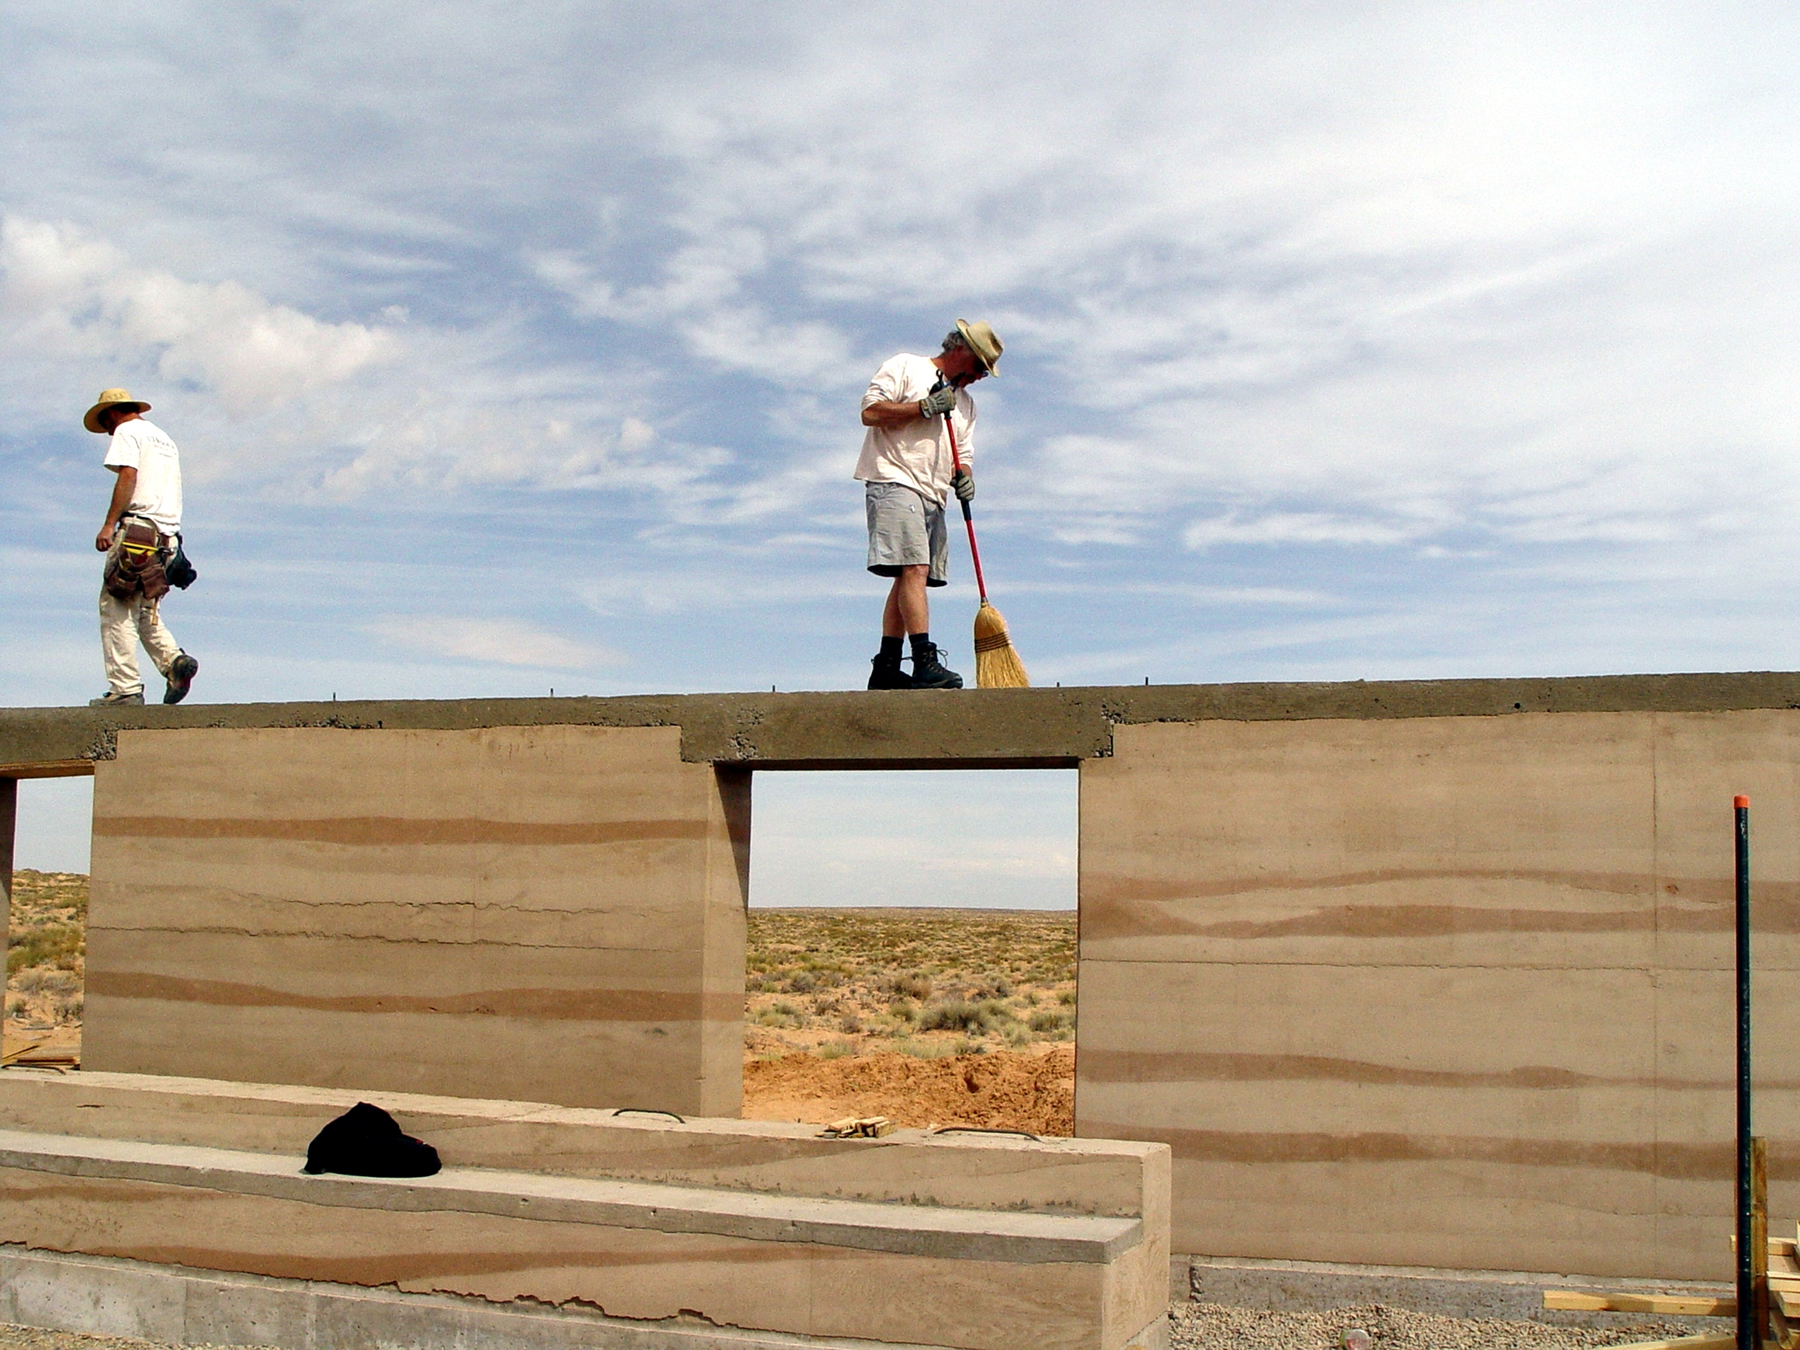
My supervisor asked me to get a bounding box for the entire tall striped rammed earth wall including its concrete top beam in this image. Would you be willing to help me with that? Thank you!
[0,673,1800,1278]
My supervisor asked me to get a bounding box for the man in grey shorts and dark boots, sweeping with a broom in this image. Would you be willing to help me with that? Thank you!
[855,319,1003,689]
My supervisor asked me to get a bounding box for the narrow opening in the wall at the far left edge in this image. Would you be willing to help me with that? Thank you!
[0,778,94,1066]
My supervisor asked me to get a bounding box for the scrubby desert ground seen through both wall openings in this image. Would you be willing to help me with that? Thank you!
[4,869,1075,1134]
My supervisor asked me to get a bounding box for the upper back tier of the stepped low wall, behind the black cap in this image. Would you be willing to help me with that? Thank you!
[0,1069,1168,1224]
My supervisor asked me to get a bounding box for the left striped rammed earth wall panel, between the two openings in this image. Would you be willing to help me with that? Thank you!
[83,727,749,1114]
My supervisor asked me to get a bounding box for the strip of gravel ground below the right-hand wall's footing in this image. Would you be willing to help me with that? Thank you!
[1170,1303,1706,1350]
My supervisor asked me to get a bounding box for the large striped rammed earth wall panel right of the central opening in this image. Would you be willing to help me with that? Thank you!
[1076,709,1800,1278]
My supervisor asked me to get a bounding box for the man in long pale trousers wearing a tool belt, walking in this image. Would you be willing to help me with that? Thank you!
[81,389,200,707]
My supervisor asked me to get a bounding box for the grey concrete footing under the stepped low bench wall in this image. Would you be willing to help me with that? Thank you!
[0,1246,1168,1350]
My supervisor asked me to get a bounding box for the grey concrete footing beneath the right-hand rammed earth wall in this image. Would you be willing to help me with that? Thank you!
[1170,1256,1732,1330]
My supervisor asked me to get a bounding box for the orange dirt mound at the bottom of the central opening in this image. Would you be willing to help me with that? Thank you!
[743,1046,1075,1134]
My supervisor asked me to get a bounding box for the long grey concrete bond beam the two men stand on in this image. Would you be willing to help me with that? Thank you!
[10,671,1800,778]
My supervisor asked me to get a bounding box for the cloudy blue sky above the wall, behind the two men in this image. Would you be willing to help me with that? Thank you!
[0,0,1800,892]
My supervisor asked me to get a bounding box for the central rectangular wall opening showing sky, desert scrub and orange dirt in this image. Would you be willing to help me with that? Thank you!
[743,769,1078,1134]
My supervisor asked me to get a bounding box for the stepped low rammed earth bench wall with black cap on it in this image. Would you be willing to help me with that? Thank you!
[0,1071,1170,1350]
